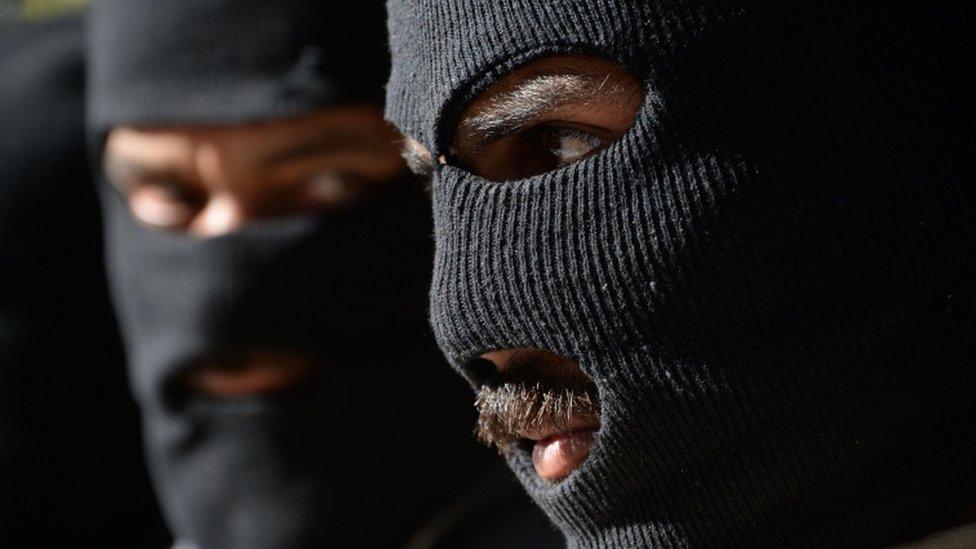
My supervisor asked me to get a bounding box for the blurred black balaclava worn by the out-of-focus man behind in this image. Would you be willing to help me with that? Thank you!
[89,0,480,549]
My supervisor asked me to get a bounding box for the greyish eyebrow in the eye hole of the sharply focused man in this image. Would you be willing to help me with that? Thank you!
[457,74,614,147]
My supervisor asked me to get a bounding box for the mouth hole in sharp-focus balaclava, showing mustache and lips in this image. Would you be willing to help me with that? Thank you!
[464,348,601,482]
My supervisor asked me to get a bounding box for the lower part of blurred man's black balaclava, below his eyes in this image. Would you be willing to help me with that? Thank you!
[102,183,477,548]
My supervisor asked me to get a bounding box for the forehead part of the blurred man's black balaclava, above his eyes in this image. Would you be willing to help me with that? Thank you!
[88,0,389,127]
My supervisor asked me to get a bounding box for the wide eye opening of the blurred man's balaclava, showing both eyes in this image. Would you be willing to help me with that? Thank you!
[103,105,402,238]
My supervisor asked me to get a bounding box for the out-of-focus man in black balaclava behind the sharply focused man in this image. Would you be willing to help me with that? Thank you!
[89,0,560,549]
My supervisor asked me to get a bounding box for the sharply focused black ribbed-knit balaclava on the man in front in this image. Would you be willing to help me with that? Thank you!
[387,0,976,547]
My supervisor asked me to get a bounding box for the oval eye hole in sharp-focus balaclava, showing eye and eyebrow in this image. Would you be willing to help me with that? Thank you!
[444,55,644,182]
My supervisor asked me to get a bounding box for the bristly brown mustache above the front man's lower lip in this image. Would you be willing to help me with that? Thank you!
[475,357,600,454]
